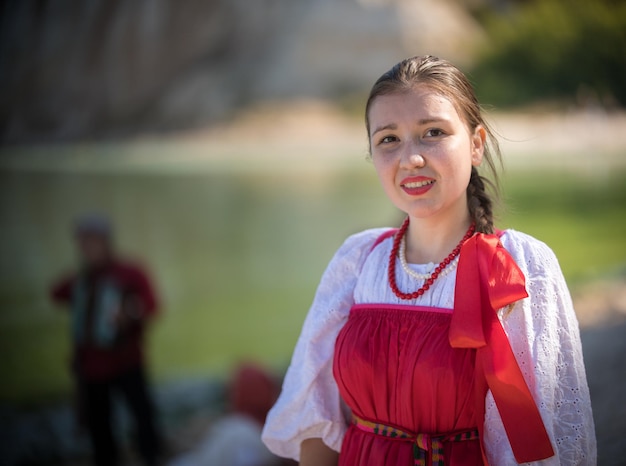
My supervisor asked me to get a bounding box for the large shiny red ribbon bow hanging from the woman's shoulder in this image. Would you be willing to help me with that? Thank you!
[449,234,554,463]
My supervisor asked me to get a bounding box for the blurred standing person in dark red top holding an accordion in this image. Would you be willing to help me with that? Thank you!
[51,214,159,466]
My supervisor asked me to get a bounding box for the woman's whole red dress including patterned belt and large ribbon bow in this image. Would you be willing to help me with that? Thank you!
[333,231,553,466]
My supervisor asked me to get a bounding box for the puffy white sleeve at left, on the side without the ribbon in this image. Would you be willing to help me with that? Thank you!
[262,230,384,461]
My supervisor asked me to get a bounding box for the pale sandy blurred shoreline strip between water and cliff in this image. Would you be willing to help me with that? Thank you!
[0,100,626,175]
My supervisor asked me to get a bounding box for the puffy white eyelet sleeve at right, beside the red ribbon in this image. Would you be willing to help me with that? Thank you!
[484,231,596,466]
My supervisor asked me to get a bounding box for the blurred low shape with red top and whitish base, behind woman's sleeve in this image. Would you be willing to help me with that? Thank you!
[169,364,295,466]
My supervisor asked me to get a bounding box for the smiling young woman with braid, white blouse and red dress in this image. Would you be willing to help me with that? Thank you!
[263,56,596,466]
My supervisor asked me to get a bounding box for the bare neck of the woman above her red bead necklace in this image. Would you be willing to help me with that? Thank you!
[406,211,471,264]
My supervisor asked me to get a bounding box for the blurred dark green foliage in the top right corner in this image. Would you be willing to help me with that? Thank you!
[470,0,626,107]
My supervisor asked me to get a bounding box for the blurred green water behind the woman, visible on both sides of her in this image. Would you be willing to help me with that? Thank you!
[0,159,626,403]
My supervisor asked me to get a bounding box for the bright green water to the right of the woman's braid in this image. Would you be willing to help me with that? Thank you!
[502,171,626,287]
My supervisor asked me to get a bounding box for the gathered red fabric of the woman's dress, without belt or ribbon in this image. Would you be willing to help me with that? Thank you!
[334,305,483,466]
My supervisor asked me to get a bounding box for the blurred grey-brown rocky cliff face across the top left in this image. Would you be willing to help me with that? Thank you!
[0,0,481,142]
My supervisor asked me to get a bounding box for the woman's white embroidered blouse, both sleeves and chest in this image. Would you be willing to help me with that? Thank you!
[263,229,596,466]
